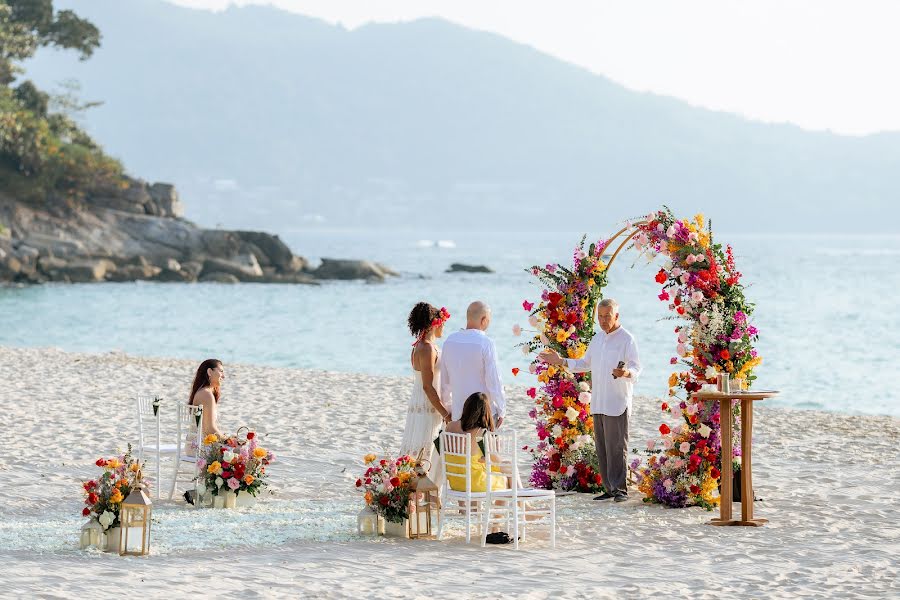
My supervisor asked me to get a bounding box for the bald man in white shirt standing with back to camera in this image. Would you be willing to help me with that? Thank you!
[441,301,506,427]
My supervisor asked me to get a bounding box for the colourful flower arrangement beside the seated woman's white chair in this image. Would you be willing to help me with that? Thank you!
[197,431,275,496]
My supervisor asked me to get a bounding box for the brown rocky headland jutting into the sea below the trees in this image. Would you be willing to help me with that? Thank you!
[0,178,397,285]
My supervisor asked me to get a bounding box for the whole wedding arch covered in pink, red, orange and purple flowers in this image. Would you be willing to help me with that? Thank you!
[522,207,762,509]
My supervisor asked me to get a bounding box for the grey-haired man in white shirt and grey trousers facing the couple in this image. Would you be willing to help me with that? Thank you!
[540,298,641,502]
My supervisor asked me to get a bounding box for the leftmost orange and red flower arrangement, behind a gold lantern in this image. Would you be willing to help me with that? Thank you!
[81,444,148,530]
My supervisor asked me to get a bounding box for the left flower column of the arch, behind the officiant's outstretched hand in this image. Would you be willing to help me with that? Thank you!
[518,238,606,492]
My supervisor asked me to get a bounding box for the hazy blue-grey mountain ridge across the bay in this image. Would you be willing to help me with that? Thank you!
[19,0,900,232]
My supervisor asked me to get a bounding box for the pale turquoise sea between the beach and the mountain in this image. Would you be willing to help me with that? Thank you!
[0,231,900,416]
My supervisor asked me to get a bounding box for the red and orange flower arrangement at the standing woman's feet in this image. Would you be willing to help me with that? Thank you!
[356,454,417,523]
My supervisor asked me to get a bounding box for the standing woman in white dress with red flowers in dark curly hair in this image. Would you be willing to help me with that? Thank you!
[400,302,450,485]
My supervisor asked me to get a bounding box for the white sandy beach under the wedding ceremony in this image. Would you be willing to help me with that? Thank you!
[0,348,900,598]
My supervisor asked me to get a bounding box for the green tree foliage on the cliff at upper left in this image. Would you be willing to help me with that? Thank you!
[0,0,122,200]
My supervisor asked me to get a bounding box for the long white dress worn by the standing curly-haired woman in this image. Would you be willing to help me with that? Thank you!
[400,344,444,486]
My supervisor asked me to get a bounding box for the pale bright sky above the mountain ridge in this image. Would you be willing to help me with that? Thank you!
[169,0,900,134]
